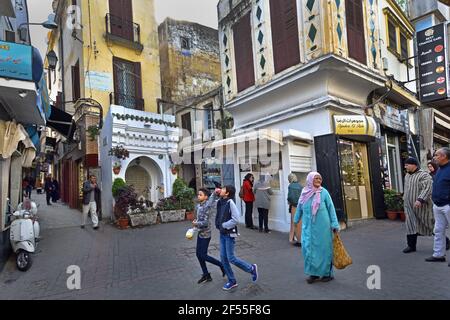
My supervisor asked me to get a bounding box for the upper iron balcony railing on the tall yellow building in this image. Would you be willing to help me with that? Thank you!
[105,13,143,51]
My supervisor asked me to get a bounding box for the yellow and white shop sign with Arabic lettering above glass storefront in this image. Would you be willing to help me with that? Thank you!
[333,116,377,137]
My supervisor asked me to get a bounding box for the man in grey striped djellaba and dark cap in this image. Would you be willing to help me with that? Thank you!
[403,158,434,253]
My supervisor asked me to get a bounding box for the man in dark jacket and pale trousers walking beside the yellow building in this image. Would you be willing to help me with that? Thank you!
[81,175,101,230]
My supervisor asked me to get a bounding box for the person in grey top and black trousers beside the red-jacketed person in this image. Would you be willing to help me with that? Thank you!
[253,174,273,233]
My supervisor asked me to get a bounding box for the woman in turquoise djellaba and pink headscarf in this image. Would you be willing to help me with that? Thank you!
[294,172,339,283]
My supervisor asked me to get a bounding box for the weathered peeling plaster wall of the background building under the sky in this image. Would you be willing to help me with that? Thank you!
[158,18,221,102]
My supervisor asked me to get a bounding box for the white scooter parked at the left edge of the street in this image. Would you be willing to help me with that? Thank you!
[9,199,40,271]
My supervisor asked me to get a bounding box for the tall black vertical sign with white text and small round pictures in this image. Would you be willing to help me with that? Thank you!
[417,23,449,103]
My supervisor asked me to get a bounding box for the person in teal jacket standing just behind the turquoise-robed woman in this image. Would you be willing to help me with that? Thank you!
[287,173,302,247]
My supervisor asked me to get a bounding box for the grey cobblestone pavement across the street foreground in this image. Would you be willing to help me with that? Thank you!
[0,195,450,300]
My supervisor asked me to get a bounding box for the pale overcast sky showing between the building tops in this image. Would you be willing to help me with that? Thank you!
[28,0,218,56]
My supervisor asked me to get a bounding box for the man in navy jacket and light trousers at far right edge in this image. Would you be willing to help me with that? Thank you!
[425,148,450,267]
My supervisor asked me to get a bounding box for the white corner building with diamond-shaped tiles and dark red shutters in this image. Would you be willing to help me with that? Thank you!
[213,0,421,231]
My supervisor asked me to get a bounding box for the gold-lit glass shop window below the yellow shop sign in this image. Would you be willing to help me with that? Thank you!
[339,139,373,220]
